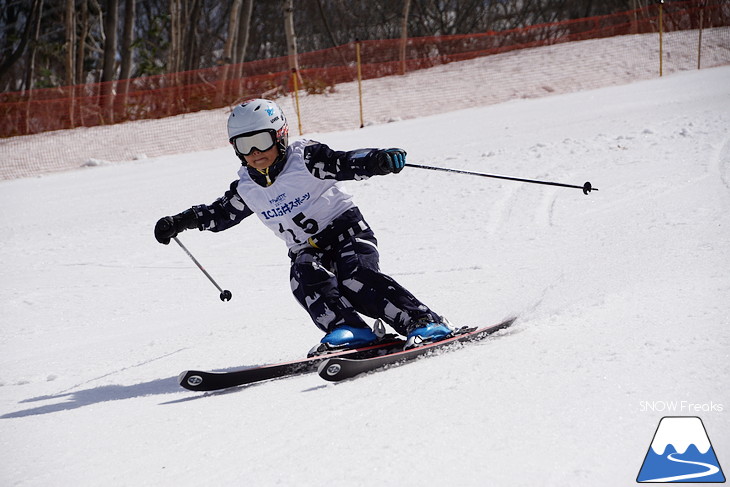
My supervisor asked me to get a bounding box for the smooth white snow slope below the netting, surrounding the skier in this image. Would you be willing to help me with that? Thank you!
[0,63,730,486]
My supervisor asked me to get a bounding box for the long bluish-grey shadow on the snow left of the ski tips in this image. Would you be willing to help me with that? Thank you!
[0,377,180,419]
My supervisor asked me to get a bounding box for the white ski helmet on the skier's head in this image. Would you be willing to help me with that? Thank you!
[228,98,289,164]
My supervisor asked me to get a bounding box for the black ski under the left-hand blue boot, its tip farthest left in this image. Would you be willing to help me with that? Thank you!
[178,335,405,392]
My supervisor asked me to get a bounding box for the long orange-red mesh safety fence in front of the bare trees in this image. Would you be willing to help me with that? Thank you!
[0,0,730,137]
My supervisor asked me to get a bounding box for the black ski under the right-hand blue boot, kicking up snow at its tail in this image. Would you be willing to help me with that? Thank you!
[317,318,516,382]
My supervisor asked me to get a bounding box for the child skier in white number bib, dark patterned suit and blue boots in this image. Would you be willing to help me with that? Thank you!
[155,99,452,353]
